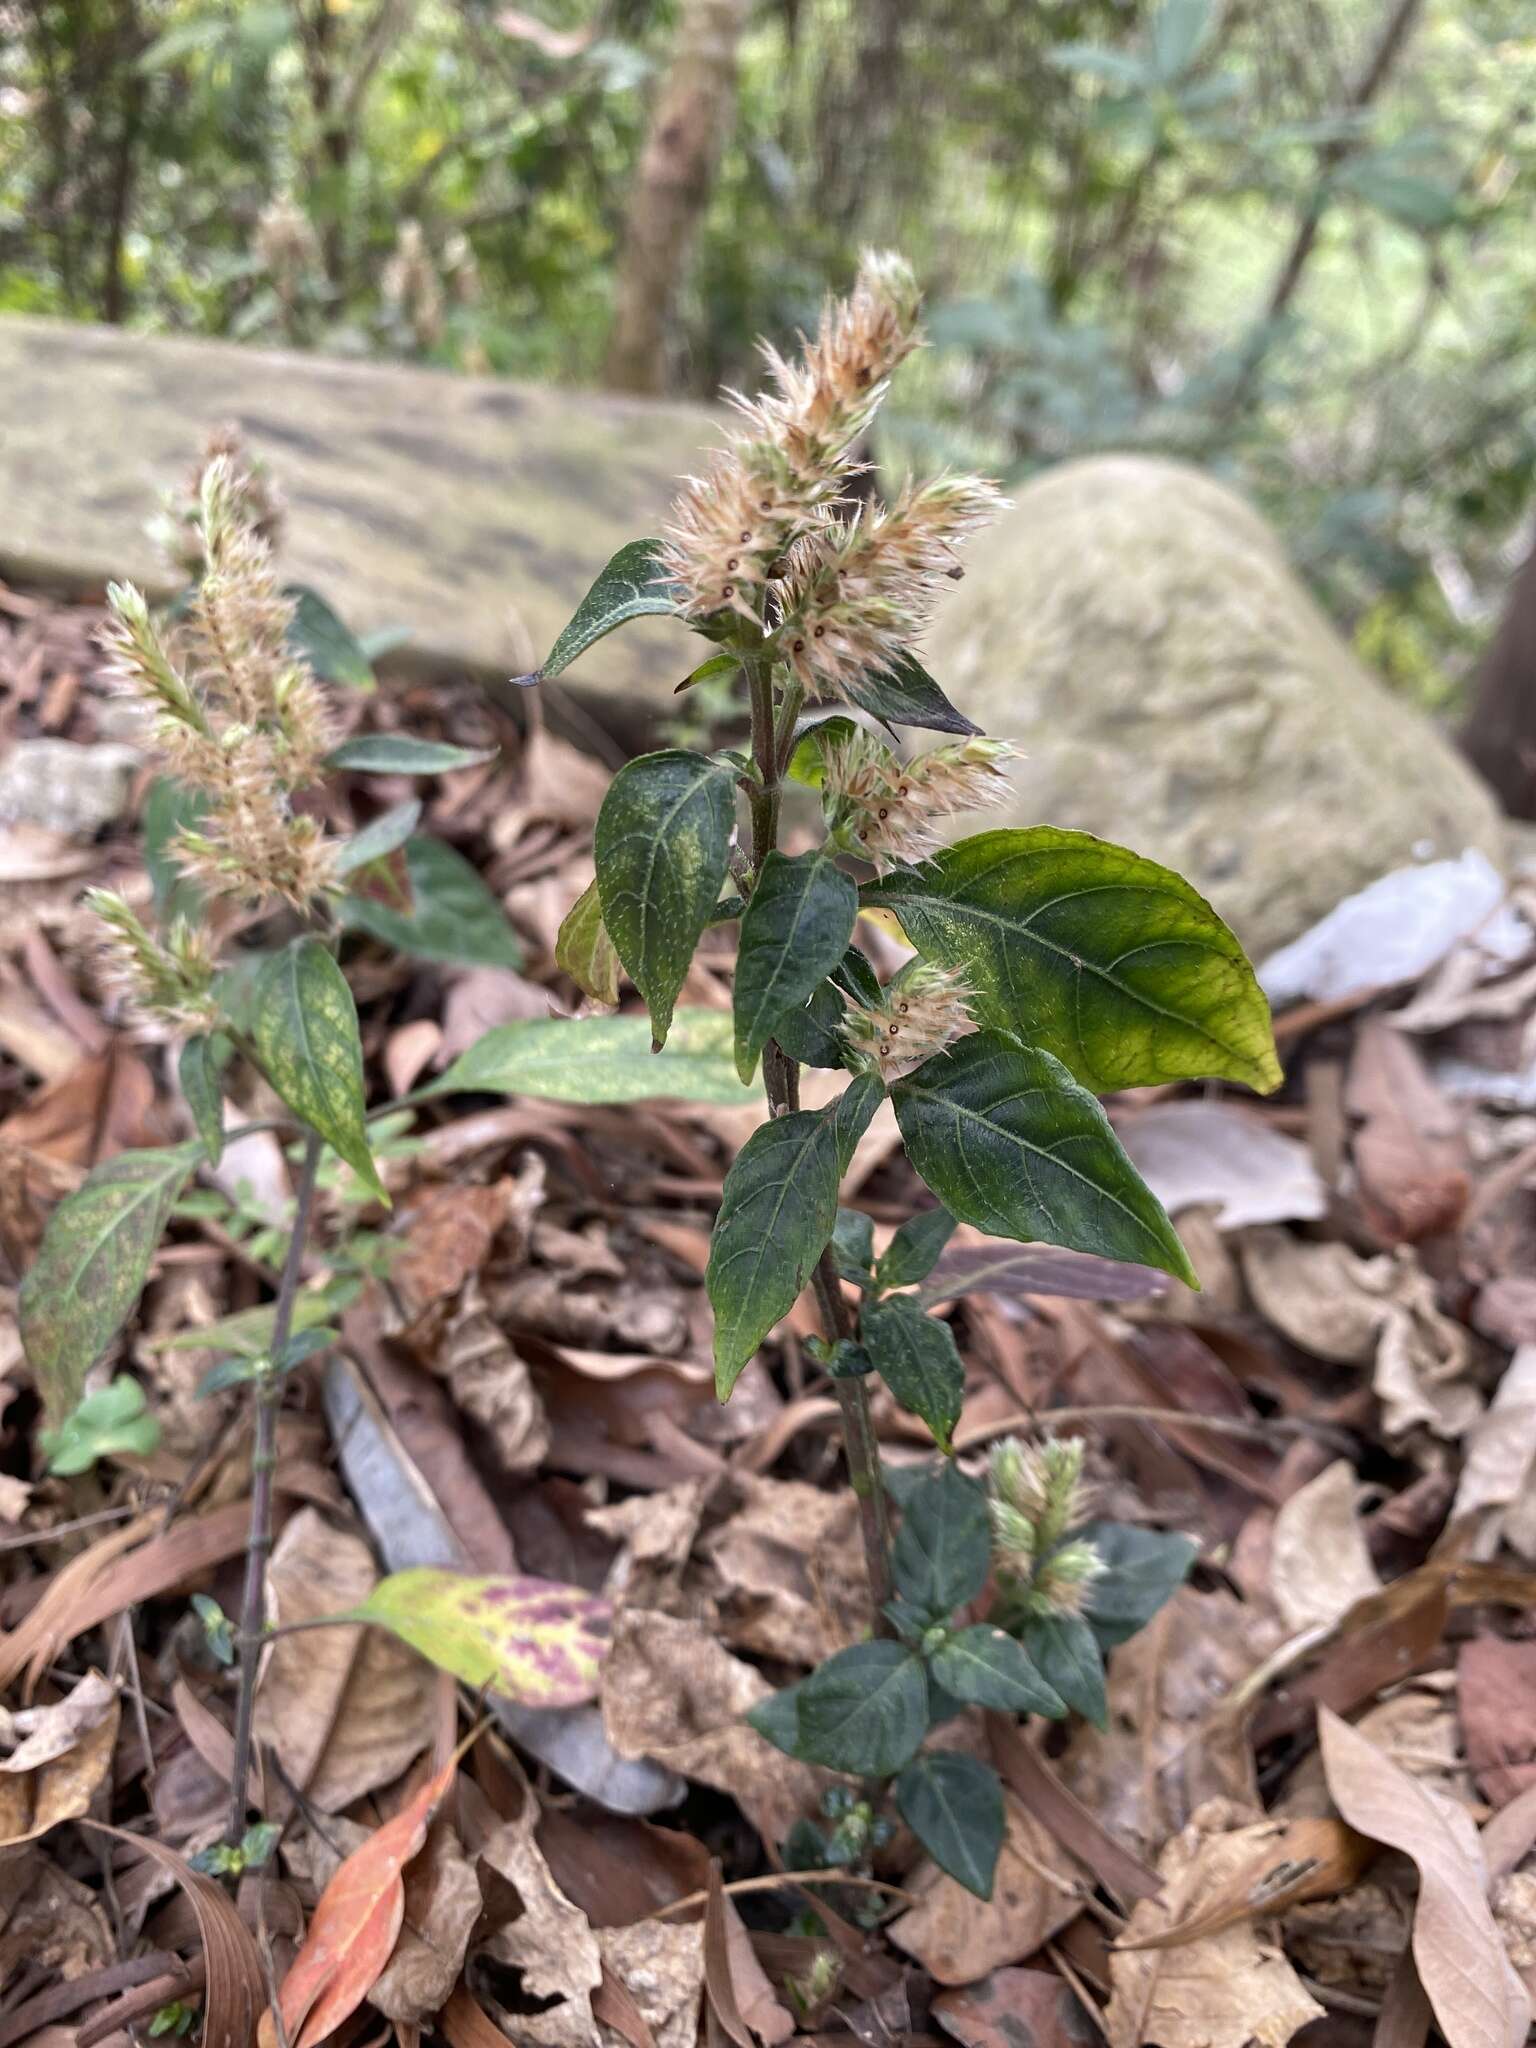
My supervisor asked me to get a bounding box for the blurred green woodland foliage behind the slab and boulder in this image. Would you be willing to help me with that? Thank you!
[0,0,1536,705]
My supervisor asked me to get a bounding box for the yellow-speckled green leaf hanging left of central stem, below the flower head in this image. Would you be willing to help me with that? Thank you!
[594,748,735,1049]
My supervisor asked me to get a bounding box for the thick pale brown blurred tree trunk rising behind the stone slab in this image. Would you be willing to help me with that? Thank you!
[604,0,748,391]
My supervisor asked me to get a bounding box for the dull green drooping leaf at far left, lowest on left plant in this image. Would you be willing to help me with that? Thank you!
[18,1143,203,1417]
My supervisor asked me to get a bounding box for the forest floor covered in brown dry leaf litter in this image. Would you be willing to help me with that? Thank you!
[0,573,1536,2048]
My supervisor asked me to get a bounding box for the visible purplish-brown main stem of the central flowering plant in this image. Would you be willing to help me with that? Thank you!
[741,653,891,1634]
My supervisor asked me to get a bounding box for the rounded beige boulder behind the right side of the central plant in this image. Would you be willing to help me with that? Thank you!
[928,457,1501,954]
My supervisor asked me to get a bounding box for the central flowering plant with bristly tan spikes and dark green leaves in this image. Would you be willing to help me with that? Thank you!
[536,256,1280,1896]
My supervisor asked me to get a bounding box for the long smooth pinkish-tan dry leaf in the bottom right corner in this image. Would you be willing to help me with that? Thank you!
[1317,1708,1530,2048]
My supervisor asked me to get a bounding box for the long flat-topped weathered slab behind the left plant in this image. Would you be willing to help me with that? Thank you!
[0,317,715,727]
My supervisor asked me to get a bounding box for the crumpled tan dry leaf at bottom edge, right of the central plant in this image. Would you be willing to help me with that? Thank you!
[1104,1800,1323,2048]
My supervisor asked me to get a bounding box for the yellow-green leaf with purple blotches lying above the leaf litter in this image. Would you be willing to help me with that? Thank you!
[346,1567,612,1706]
